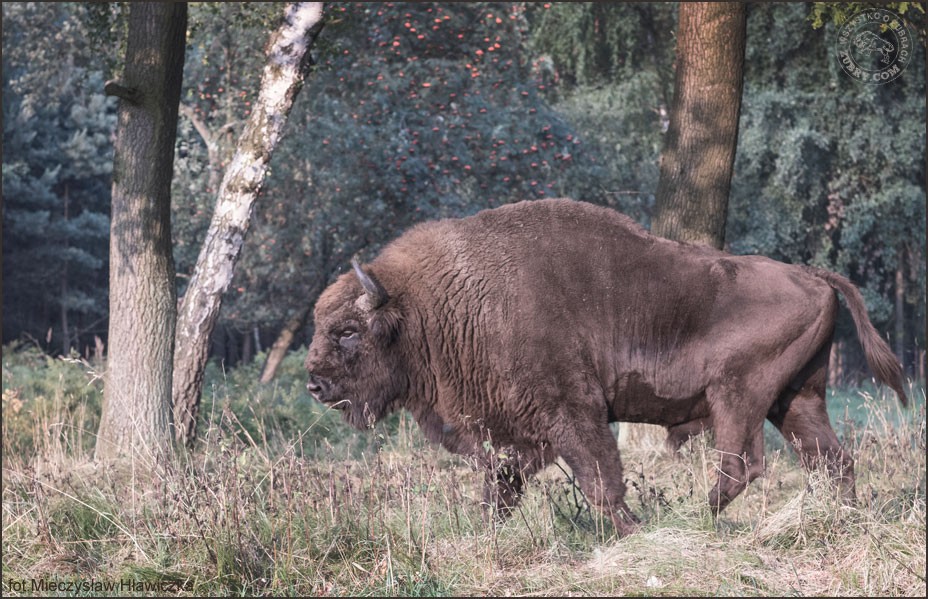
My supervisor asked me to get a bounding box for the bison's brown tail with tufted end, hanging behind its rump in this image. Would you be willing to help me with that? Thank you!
[806,267,908,405]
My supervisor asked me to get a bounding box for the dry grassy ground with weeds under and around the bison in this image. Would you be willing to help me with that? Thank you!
[2,347,926,597]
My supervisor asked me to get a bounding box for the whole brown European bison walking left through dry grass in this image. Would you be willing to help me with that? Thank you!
[306,199,906,534]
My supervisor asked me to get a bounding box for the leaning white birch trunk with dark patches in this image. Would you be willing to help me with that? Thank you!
[173,2,323,445]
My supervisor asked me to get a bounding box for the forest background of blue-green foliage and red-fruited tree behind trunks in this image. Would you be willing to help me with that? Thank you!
[3,3,925,382]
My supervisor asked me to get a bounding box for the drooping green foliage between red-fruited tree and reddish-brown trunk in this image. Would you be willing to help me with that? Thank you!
[527,2,677,225]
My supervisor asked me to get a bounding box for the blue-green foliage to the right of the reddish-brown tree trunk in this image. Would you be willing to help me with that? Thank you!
[727,5,925,359]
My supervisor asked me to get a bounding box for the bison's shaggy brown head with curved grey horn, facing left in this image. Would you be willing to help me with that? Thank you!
[306,260,407,428]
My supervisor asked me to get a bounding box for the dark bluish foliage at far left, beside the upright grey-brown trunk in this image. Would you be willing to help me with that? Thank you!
[3,3,115,354]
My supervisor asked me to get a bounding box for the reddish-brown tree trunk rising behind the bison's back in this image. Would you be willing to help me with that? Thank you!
[651,2,746,249]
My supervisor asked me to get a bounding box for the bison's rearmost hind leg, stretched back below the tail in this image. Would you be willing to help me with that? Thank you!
[767,344,856,503]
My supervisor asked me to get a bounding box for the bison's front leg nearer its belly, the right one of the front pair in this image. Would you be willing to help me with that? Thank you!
[552,413,640,536]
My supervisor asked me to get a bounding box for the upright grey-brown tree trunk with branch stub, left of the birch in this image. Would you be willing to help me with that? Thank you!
[96,2,187,463]
